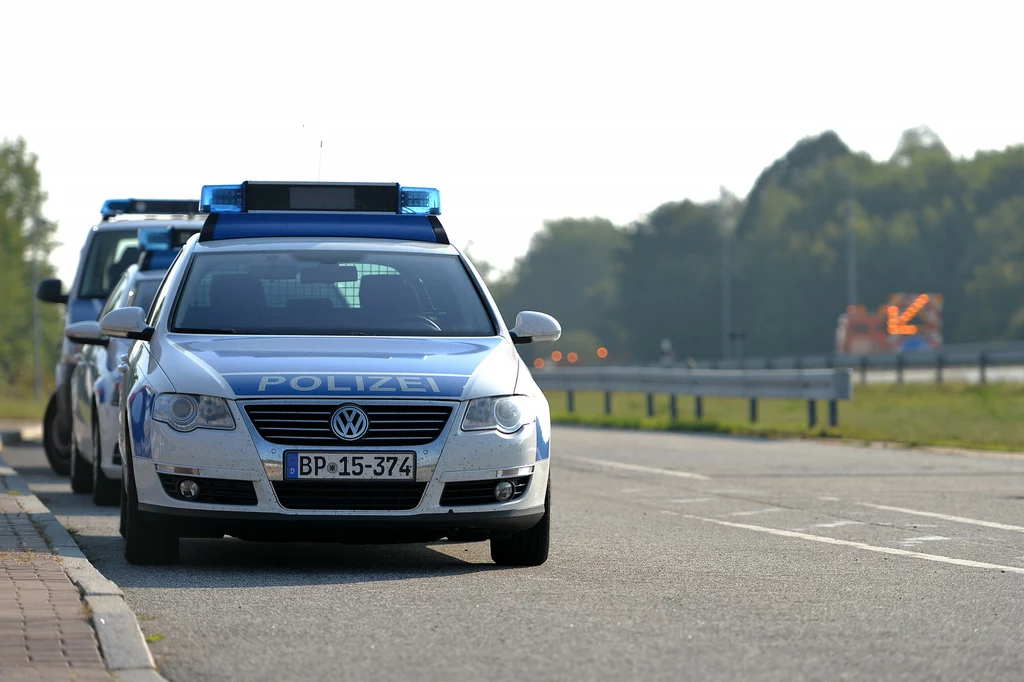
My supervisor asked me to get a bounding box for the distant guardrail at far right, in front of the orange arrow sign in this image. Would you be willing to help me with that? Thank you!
[696,344,1024,384]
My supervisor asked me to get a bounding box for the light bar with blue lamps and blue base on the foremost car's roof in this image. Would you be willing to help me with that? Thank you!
[199,181,449,244]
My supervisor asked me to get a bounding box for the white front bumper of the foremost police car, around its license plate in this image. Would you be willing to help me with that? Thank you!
[132,404,549,542]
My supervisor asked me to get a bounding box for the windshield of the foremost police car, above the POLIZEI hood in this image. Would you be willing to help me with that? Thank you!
[171,250,497,336]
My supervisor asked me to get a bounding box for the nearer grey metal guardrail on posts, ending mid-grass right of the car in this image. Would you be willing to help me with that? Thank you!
[534,367,853,428]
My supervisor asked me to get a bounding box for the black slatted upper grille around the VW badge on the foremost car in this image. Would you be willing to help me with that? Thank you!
[246,400,452,446]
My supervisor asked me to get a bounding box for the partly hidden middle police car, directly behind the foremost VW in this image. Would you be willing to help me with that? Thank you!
[65,225,200,505]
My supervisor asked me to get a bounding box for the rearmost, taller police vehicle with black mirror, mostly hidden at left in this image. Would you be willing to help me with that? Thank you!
[36,199,202,476]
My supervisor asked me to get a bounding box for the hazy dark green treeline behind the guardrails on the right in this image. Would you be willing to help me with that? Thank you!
[484,128,1024,363]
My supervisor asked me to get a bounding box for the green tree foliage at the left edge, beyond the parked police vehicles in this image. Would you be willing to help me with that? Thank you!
[0,138,62,387]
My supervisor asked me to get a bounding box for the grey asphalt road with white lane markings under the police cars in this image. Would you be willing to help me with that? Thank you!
[3,428,1024,682]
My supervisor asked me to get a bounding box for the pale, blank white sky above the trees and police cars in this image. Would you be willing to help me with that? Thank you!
[0,0,1024,281]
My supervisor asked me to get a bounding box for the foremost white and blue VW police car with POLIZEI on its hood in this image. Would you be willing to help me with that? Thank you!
[101,182,561,565]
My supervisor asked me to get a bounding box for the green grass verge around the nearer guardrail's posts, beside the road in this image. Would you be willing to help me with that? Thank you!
[547,384,1024,451]
